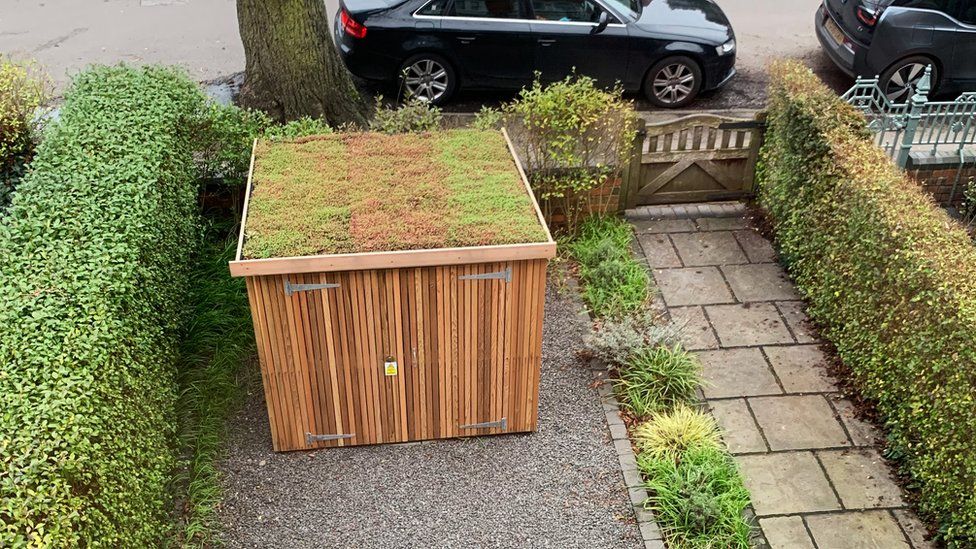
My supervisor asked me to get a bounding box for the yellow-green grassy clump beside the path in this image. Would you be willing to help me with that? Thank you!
[633,404,722,461]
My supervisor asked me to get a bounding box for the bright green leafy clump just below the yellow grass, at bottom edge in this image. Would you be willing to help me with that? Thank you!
[637,445,751,549]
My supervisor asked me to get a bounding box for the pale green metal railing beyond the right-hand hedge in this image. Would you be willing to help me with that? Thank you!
[841,65,976,168]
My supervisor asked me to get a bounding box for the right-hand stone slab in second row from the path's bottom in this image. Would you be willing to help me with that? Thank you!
[817,448,905,509]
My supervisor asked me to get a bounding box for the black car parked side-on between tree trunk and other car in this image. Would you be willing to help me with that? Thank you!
[335,0,735,107]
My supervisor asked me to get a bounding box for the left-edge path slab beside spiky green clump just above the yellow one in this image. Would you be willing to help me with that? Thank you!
[698,347,783,398]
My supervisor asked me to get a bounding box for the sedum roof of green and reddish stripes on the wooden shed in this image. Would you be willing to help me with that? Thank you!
[243,129,546,259]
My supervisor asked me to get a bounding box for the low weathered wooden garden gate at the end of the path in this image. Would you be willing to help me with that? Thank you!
[621,113,765,208]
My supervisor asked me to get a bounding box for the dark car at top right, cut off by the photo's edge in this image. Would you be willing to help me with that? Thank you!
[816,0,976,103]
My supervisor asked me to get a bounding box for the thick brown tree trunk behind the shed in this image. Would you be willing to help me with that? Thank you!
[237,0,366,126]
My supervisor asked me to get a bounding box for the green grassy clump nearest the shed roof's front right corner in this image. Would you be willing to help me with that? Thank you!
[567,216,650,316]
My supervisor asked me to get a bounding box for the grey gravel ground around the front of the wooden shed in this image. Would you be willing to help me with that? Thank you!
[219,288,641,549]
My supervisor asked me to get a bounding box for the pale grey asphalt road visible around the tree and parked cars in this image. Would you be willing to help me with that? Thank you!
[0,0,851,111]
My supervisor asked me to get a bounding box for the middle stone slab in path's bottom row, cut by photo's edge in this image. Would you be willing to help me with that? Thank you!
[807,511,910,549]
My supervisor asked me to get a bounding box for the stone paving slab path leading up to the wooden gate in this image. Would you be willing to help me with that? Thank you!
[628,203,934,549]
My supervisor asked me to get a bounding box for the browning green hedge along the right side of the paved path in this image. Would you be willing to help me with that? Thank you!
[760,63,976,547]
